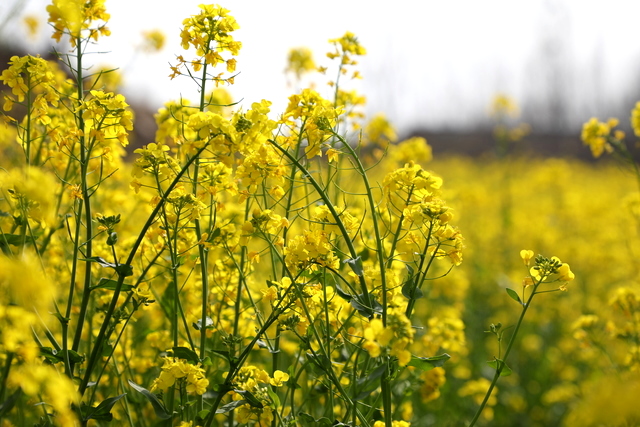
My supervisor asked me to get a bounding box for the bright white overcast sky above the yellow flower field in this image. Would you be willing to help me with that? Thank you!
[0,0,640,131]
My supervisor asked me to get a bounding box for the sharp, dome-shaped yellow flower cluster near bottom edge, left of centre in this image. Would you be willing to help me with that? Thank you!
[151,357,209,394]
